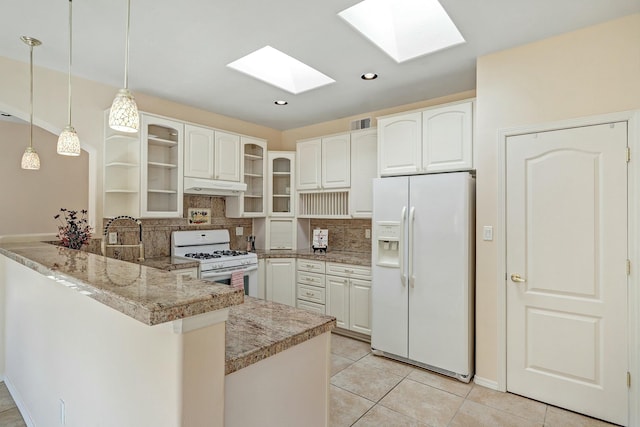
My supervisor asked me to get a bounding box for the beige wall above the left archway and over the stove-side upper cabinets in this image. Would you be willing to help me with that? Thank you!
[0,57,281,227]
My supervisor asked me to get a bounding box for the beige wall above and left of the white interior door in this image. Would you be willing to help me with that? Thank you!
[475,14,640,380]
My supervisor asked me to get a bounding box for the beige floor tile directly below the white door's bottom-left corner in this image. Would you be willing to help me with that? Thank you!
[467,384,547,423]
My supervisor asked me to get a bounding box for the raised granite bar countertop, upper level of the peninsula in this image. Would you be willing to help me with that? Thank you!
[0,242,244,325]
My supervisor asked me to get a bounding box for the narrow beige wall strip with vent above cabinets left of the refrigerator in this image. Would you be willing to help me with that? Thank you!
[278,90,476,151]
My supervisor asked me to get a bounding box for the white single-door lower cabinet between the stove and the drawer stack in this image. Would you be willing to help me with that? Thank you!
[265,258,296,307]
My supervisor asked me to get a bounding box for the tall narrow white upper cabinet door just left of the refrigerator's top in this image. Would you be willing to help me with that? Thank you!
[349,129,378,218]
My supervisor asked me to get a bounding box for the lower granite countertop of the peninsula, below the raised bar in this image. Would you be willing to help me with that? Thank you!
[225,296,336,375]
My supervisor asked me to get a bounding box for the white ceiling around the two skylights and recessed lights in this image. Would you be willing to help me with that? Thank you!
[0,0,640,130]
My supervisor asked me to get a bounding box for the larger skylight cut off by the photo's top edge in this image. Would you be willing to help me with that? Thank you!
[338,0,465,62]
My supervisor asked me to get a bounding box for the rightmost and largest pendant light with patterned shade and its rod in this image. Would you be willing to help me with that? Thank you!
[109,0,140,132]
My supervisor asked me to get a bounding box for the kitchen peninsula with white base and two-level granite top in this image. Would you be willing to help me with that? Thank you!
[0,243,335,426]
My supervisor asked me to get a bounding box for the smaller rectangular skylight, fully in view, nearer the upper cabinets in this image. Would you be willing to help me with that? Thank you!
[227,46,335,95]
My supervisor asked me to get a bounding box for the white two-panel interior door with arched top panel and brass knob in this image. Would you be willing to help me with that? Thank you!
[506,122,628,425]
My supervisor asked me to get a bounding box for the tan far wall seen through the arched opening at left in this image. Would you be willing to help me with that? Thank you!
[0,121,89,236]
